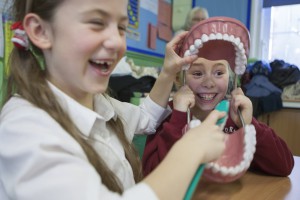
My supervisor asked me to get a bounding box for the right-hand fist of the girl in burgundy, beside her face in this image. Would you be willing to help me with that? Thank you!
[230,88,253,128]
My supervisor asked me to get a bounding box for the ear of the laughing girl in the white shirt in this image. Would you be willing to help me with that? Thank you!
[23,13,51,50]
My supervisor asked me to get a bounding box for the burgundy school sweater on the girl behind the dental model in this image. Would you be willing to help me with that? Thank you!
[142,102,294,176]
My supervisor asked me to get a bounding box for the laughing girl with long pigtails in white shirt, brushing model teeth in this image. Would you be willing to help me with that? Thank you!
[0,0,225,200]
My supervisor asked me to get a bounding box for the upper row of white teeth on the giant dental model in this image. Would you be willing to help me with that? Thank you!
[184,33,247,75]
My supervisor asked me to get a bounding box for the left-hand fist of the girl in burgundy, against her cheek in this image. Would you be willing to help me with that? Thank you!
[173,85,195,112]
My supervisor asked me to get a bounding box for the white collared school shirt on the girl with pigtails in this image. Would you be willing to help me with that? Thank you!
[0,83,170,200]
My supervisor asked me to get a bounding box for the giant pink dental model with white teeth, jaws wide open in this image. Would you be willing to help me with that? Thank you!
[179,17,256,183]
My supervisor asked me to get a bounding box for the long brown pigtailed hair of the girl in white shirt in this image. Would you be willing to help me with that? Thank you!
[6,0,142,193]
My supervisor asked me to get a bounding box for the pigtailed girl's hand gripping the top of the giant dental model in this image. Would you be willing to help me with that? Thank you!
[162,31,198,78]
